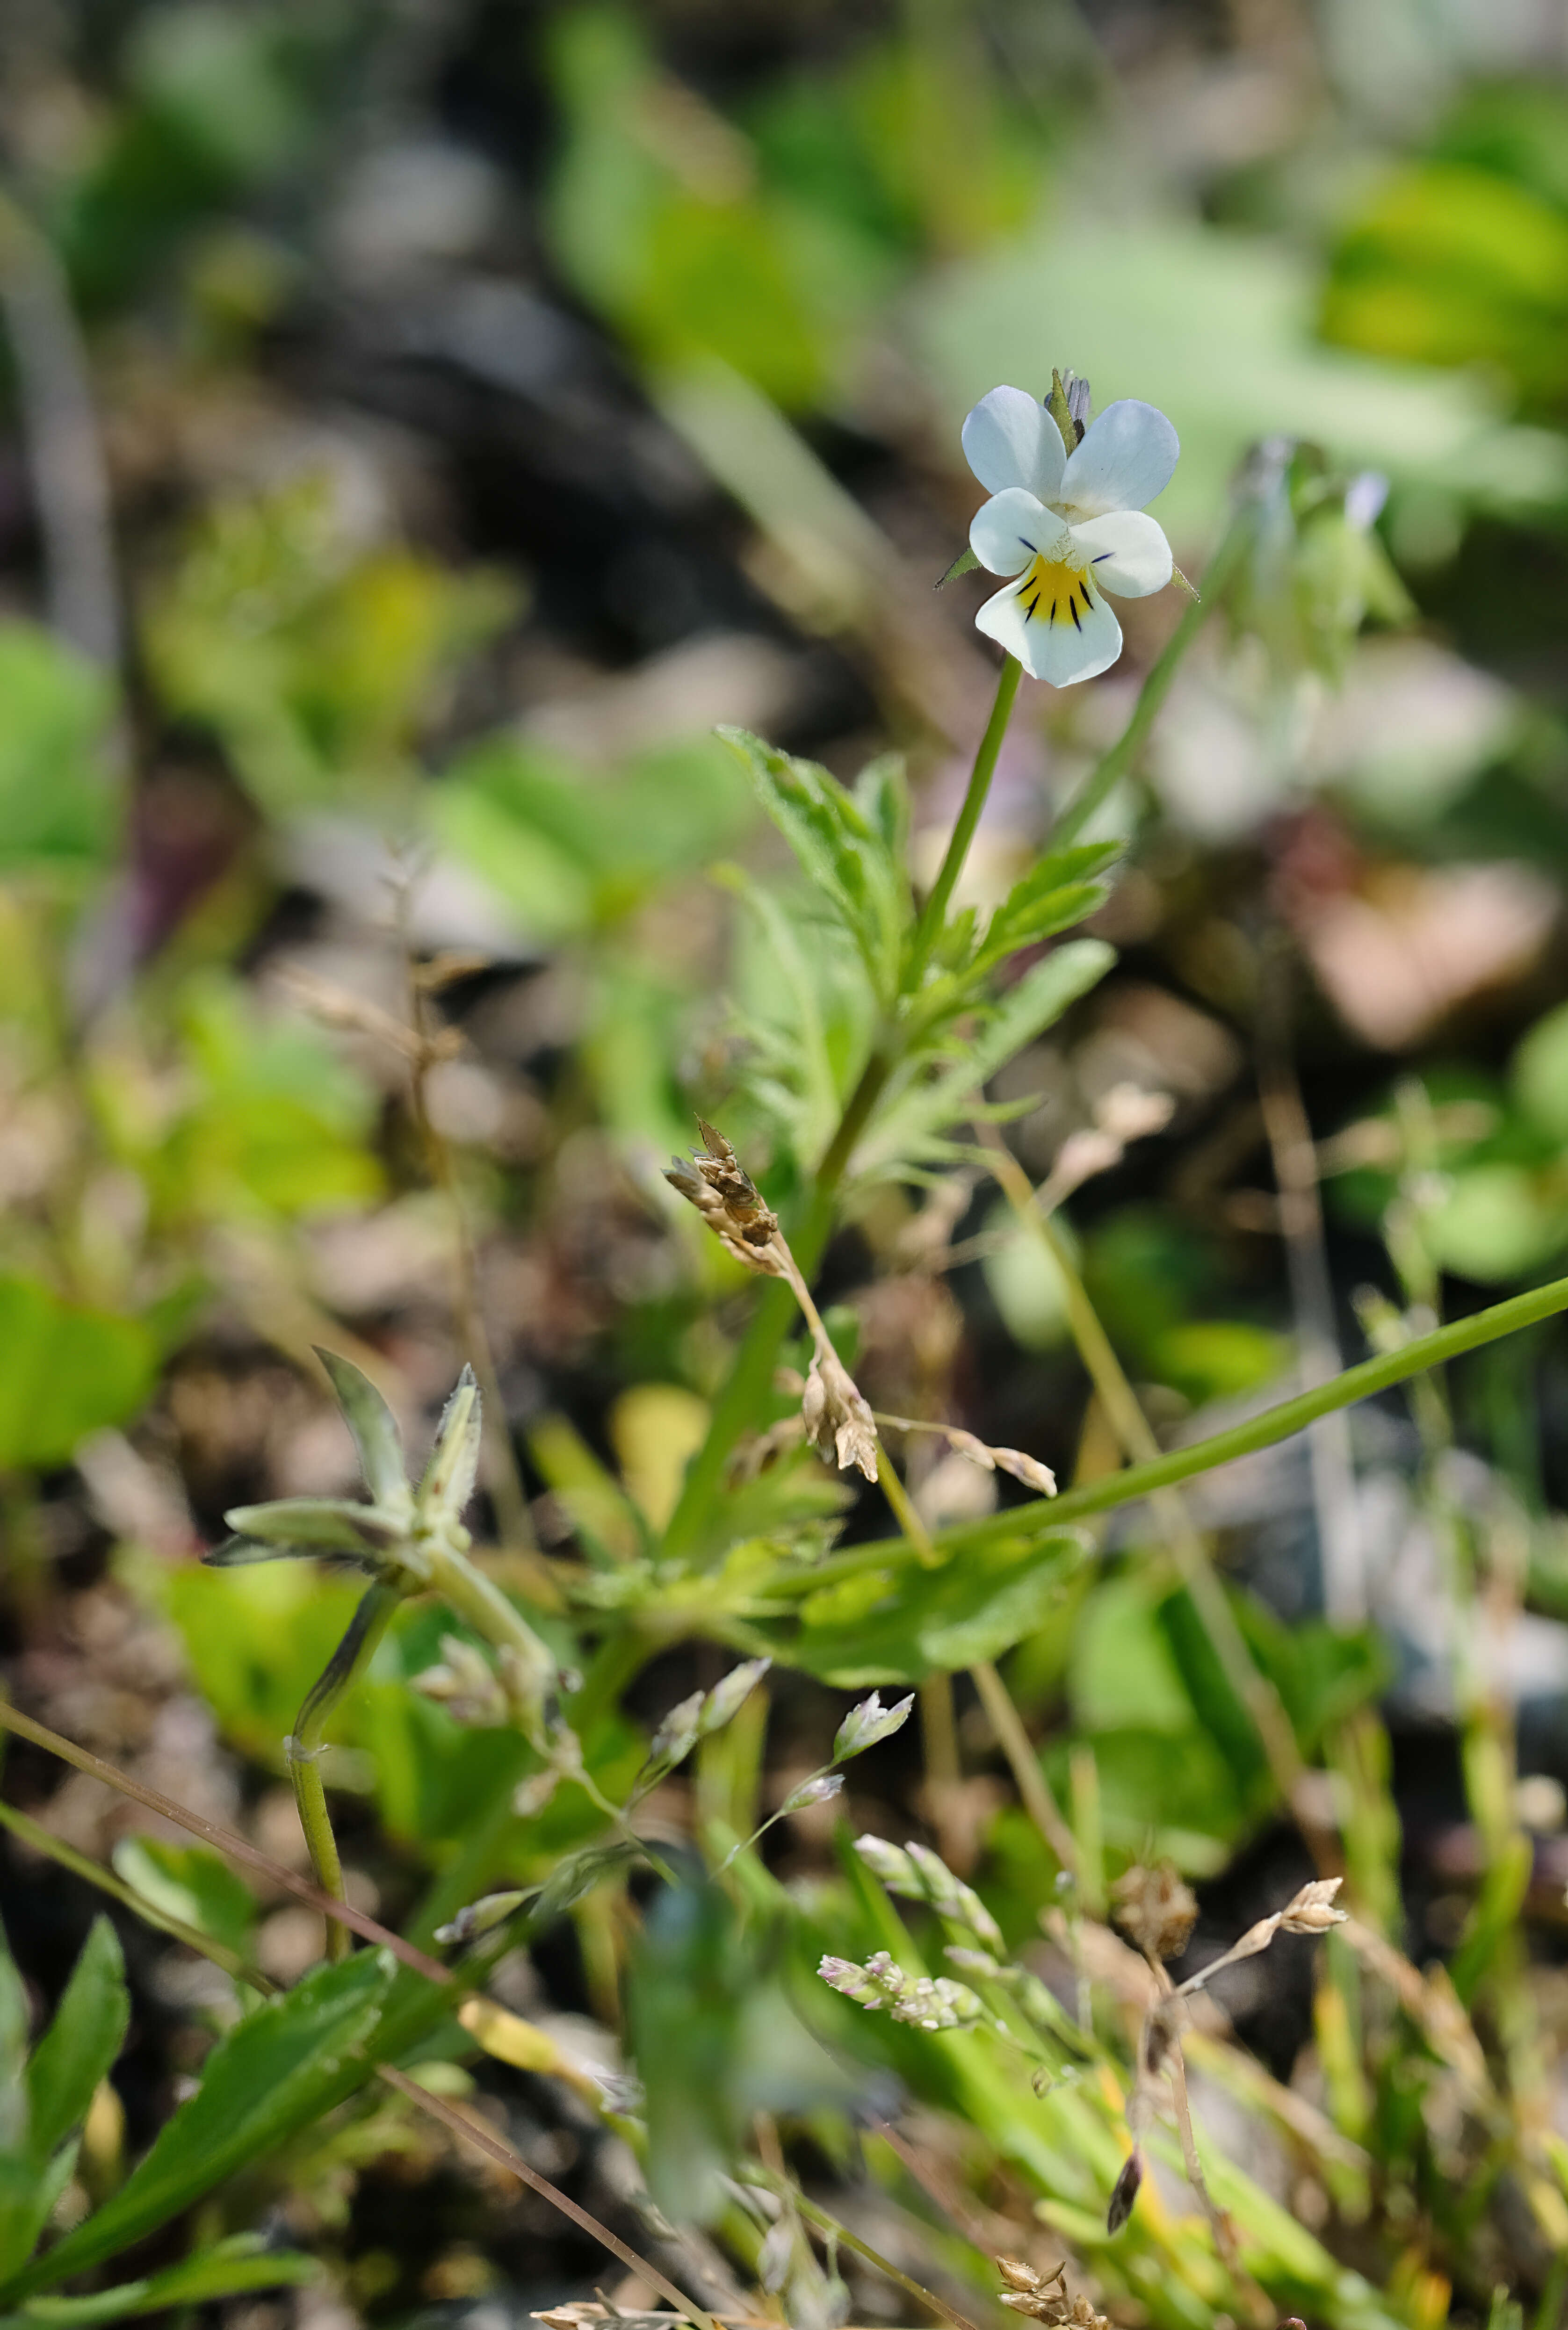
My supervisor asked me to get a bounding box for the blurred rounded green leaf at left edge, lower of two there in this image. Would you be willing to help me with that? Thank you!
[0,1277,156,1472]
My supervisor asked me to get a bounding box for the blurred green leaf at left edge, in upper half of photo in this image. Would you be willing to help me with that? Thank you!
[0,622,121,881]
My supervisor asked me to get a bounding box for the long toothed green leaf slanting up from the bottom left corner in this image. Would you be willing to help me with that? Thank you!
[19,1950,394,2295]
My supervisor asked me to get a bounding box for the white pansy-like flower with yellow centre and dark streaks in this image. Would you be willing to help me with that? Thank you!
[965,389,1181,687]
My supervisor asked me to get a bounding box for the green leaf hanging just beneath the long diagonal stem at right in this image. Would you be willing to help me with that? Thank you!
[755,1529,1088,1692]
